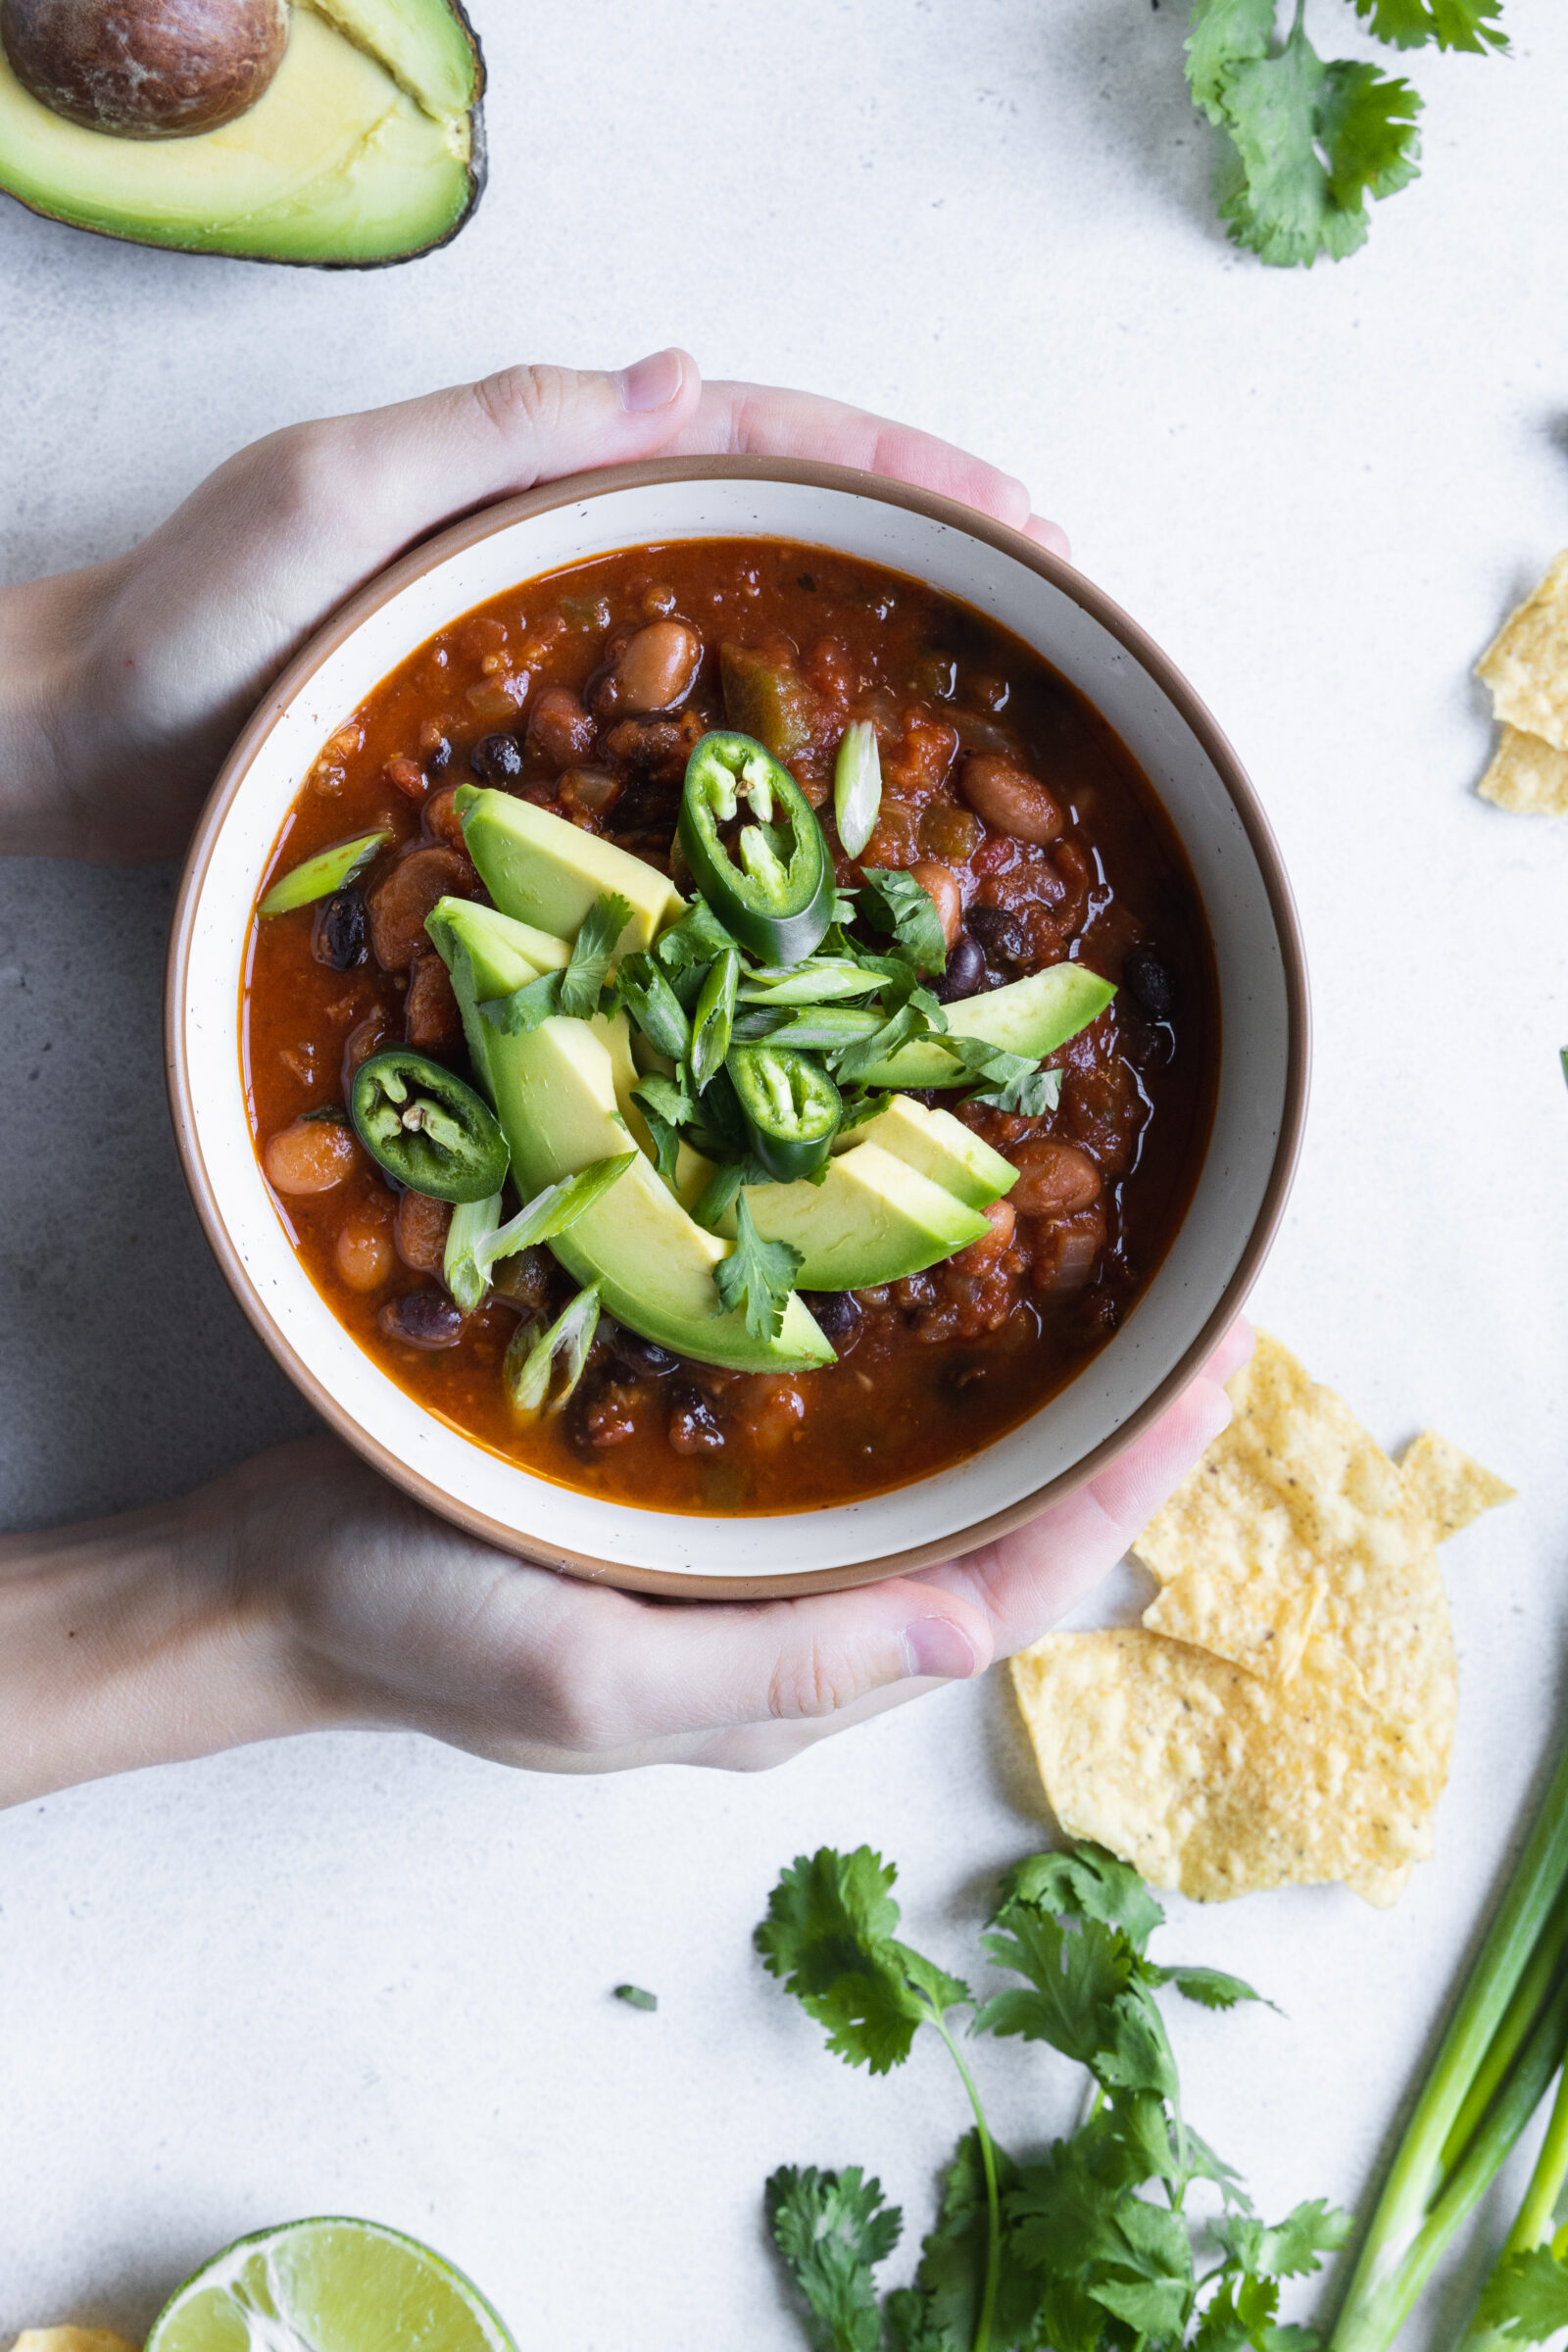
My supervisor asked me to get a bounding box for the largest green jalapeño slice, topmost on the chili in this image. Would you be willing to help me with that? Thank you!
[679,734,832,964]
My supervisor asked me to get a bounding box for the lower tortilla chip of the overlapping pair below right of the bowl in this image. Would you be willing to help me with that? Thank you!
[1013,1625,1432,1903]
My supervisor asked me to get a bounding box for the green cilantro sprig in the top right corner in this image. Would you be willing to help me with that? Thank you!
[1187,0,1507,269]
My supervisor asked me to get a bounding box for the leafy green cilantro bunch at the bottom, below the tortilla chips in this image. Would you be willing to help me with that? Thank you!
[757,1844,1353,2352]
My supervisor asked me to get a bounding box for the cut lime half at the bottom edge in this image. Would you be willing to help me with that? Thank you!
[146,2218,517,2352]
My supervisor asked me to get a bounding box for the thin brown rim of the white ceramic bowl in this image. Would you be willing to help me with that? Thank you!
[165,457,1312,1601]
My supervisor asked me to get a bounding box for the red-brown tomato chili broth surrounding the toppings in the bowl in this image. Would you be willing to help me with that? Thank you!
[242,541,1218,1512]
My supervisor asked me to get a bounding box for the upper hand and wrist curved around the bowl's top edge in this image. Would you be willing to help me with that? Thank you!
[0,351,1067,863]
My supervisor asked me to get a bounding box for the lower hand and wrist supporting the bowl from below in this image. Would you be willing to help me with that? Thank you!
[0,1324,1253,1801]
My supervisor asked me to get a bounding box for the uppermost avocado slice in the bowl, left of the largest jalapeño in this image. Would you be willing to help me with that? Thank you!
[464,793,686,955]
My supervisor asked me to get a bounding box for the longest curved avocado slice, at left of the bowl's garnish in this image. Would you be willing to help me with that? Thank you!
[430,899,835,1371]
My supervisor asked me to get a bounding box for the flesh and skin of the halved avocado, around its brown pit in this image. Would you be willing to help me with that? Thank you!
[0,0,484,269]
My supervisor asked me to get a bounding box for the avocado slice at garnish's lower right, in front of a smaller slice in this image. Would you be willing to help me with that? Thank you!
[719,1143,987,1292]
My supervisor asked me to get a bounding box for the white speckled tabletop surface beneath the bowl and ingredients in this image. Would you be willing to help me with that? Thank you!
[0,0,1568,2352]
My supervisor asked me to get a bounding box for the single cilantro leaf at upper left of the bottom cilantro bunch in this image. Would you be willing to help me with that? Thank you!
[757,1843,971,2075]
